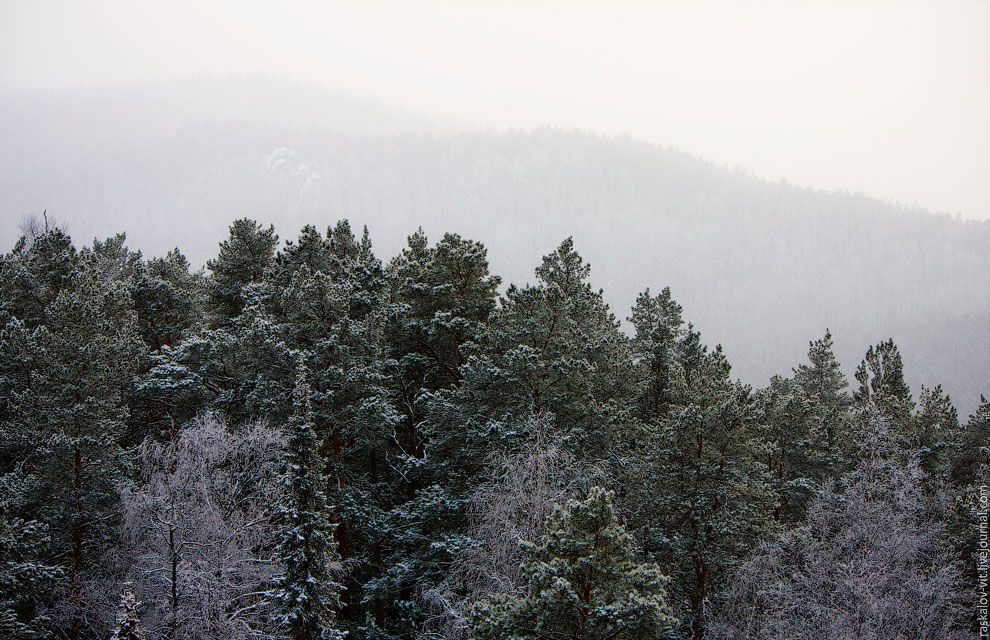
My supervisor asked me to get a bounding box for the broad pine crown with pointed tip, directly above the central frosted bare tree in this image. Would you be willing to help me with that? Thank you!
[479,238,636,459]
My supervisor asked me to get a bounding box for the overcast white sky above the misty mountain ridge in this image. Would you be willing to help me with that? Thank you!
[0,0,990,219]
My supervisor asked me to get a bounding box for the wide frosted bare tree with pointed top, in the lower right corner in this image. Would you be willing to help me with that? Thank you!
[710,418,971,640]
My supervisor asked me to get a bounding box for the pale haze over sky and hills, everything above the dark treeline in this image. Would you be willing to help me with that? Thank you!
[0,0,990,415]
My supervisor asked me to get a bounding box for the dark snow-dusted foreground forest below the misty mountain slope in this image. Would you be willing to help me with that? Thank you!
[0,218,990,640]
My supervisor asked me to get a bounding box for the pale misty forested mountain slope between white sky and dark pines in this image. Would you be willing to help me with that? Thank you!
[0,88,990,411]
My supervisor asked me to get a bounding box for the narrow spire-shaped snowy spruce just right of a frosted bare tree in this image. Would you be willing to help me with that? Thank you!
[271,366,344,640]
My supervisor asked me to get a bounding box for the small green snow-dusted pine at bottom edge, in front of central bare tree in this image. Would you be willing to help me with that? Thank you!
[471,487,676,640]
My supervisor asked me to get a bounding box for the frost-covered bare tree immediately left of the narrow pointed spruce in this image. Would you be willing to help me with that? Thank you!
[123,416,283,640]
